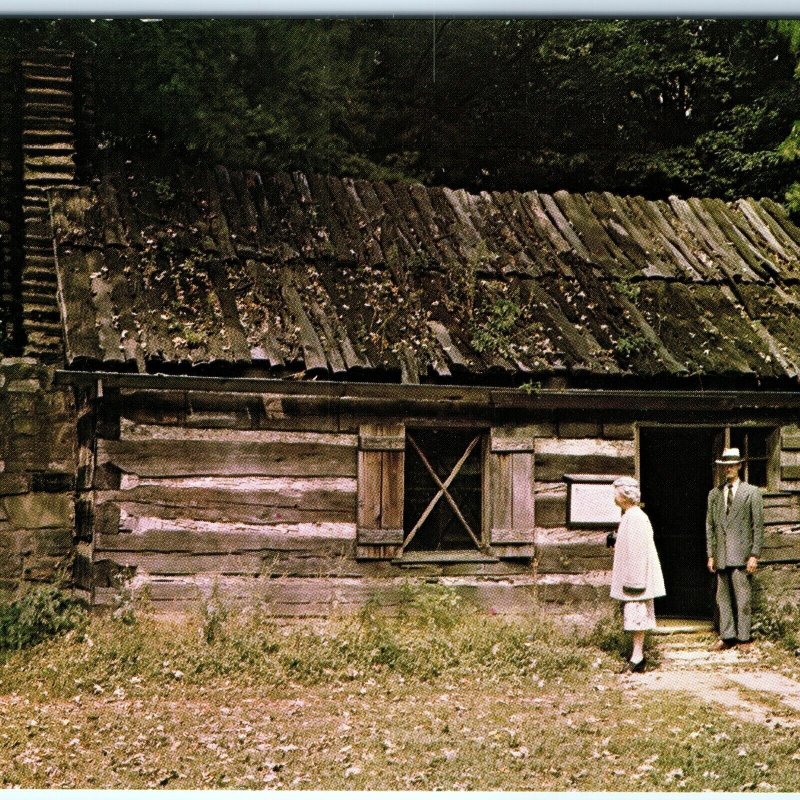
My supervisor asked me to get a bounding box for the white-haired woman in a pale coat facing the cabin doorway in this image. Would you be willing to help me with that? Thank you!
[611,478,666,672]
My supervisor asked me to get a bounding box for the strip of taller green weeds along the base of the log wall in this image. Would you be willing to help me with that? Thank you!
[0,584,592,696]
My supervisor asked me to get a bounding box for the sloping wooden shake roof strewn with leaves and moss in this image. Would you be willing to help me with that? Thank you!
[50,167,800,383]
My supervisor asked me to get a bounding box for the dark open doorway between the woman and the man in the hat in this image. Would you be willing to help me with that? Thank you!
[639,427,720,619]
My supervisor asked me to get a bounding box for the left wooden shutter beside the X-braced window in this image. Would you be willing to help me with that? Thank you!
[356,423,406,559]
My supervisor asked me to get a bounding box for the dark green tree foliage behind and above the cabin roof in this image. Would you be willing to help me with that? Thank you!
[0,19,800,199]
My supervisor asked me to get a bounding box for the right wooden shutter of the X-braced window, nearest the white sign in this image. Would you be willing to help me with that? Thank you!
[484,427,535,558]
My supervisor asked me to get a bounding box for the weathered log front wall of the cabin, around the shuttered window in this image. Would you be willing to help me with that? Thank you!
[76,389,800,614]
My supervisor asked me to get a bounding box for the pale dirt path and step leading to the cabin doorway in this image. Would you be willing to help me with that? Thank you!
[621,634,800,728]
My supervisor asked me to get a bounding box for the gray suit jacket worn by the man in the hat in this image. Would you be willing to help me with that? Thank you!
[706,481,764,569]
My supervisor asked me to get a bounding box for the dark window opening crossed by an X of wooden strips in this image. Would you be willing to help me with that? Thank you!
[402,428,482,551]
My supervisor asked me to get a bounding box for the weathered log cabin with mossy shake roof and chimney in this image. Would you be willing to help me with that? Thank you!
[1,50,800,618]
